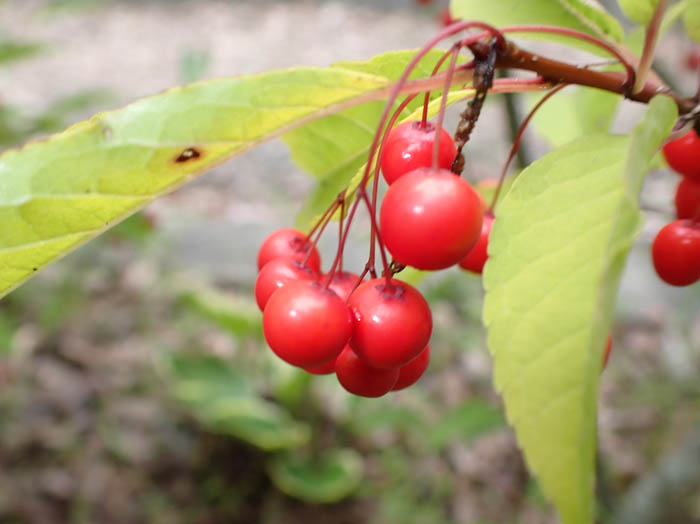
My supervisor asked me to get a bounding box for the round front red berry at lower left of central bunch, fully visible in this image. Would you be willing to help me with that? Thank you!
[263,282,352,368]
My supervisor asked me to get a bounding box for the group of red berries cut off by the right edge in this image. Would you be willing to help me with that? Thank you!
[651,129,700,286]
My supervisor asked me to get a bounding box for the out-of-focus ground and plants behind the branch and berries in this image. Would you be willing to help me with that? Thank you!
[0,0,700,524]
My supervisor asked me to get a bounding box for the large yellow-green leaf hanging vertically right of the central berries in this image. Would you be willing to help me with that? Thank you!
[484,97,676,524]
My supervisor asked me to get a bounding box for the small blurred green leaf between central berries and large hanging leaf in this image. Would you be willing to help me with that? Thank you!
[428,400,505,450]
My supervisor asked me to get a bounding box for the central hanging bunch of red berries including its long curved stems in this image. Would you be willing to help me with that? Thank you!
[255,17,644,397]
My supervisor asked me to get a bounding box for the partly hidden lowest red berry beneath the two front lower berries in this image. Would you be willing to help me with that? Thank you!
[335,346,399,397]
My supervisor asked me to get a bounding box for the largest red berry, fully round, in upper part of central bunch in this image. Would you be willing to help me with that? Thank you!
[379,169,483,269]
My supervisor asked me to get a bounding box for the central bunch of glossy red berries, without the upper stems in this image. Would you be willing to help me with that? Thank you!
[255,115,493,397]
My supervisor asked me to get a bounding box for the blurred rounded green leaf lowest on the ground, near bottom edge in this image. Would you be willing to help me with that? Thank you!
[268,449,364,504]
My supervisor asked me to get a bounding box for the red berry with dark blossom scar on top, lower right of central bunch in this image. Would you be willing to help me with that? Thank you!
[348,278,433,369]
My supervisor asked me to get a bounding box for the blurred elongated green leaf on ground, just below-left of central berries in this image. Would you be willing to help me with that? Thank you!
[163,354,310,450]
